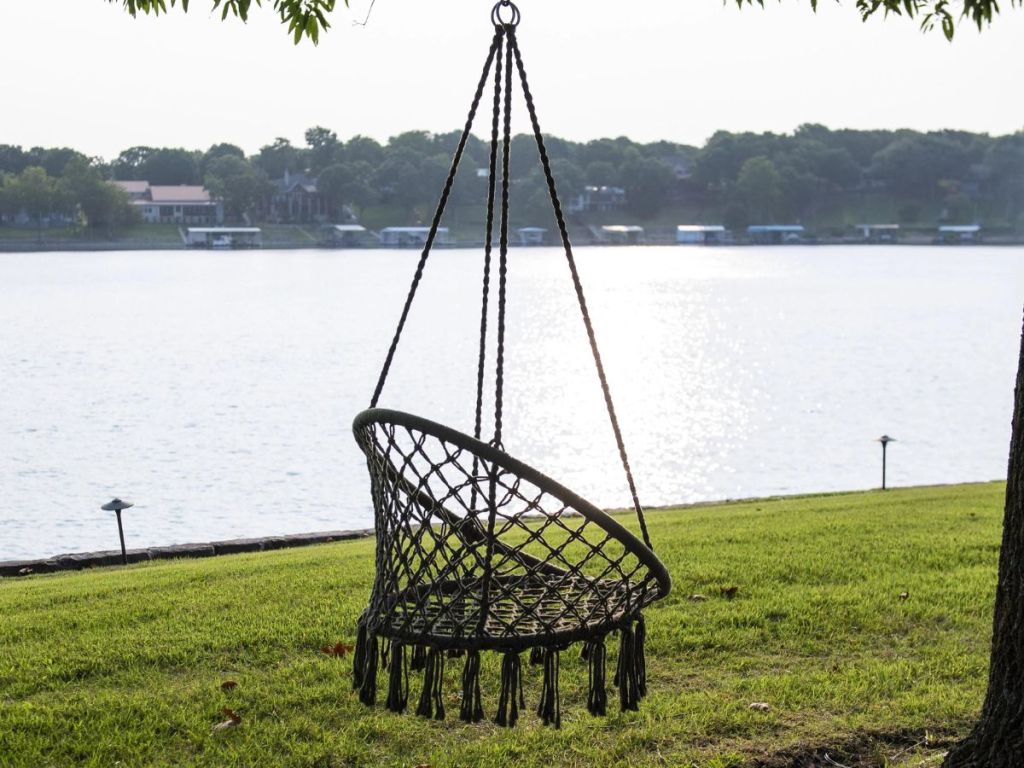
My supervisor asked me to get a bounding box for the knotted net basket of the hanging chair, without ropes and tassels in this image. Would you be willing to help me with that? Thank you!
[355,411,667,648]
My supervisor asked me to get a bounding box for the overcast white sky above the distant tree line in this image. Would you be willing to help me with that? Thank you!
[0,0,1024,158]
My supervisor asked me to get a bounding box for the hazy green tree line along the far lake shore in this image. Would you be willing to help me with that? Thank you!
[6,125,1024,229]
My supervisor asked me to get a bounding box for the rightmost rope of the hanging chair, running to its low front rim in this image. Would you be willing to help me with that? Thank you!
[507,28,654,551]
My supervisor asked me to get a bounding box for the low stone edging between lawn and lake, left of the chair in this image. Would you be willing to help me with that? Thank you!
[0,528,374,579]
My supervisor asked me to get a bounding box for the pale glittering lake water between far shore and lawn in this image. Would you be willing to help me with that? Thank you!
[0,247,1024,559]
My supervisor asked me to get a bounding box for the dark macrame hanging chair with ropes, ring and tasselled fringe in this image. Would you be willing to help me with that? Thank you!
[352,1,671,727]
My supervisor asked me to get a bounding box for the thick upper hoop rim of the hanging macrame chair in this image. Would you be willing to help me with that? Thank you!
[352,408,672,598]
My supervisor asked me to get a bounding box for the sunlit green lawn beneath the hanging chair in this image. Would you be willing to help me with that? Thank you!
[0,483,1004,768]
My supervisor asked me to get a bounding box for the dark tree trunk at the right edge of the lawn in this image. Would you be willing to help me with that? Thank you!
[943,309,1024,768]
